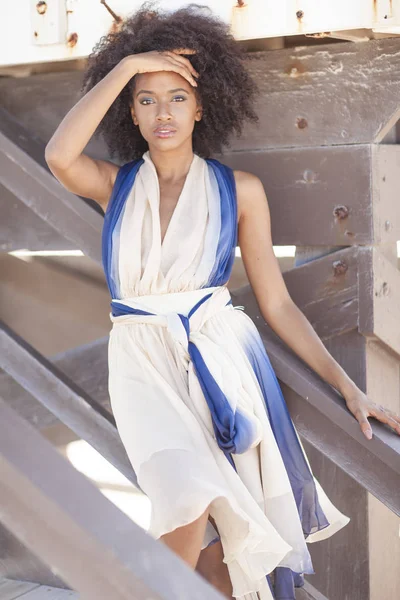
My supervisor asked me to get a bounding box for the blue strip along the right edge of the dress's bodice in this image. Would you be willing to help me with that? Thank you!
[204,158,237,287]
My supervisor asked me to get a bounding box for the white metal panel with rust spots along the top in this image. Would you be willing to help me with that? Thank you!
[0,0,400,66]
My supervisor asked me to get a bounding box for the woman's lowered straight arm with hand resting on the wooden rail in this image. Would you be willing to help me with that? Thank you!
[234,171,400,439]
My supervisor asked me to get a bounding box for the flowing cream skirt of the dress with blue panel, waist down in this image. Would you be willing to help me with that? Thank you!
[108,286,350,600]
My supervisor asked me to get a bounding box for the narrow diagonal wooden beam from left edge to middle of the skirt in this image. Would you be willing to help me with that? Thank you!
[0,324,141,489]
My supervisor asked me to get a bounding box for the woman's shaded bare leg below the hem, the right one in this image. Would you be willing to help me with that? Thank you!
[196,517,234,600]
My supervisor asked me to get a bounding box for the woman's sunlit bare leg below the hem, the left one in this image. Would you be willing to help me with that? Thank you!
[159,506,210,569]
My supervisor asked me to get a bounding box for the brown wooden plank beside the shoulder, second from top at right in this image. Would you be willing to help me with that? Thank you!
[219,145,374,246]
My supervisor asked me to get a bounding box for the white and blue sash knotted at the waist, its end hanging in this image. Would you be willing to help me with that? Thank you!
[110,286,262,454]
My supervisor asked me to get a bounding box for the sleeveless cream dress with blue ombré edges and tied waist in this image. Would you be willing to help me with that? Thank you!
[103,152,349,600]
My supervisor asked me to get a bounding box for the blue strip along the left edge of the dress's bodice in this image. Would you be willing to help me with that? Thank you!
[102,158,144,298]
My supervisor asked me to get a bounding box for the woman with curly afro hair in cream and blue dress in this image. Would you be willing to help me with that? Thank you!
[46,5,400,600]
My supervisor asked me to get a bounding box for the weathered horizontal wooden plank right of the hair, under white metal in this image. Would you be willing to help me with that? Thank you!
[231,37,400,150]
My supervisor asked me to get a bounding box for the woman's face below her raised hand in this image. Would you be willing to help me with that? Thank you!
[131,71,201,150]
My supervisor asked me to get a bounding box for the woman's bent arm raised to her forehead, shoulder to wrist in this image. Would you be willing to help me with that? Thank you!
[45,56,137,211]
